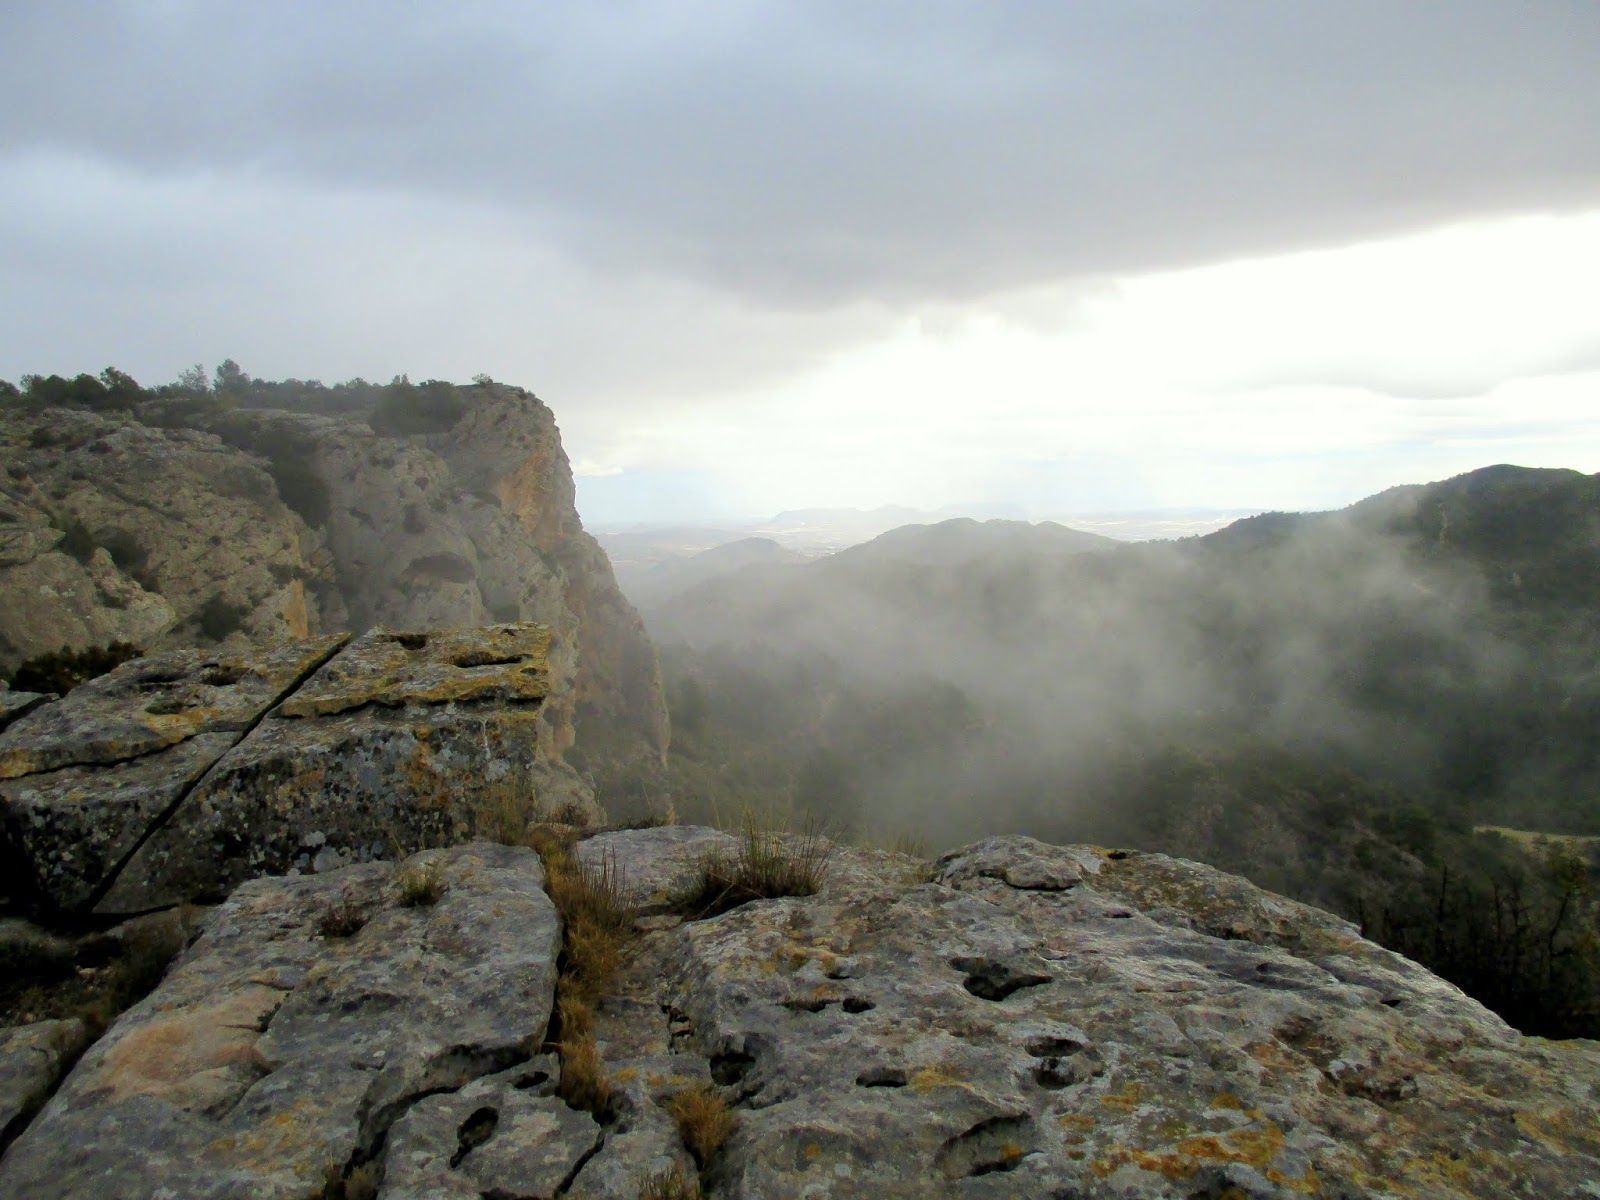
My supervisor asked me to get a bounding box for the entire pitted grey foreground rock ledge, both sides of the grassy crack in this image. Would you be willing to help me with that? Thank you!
[0,827,1600,1200]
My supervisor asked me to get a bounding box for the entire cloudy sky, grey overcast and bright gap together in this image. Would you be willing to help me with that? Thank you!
[0,0,1600,525]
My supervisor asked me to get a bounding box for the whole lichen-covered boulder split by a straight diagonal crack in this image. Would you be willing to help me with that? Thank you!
[0,624,600,915]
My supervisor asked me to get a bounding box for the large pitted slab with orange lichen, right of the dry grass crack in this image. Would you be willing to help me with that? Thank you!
[574,830,1600,1200]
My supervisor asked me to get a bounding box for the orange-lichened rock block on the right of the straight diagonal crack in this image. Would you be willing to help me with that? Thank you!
[99,624,602,912]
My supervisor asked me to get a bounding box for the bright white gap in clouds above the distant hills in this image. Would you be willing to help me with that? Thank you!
[574,213,1600,520]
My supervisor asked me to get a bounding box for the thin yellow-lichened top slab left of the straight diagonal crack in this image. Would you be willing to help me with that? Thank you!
[0,634,347,779]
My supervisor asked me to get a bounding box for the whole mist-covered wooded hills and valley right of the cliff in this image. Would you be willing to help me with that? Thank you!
[645,467,1600,1035]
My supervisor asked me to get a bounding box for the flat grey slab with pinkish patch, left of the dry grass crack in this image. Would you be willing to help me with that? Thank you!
[0,843,563,1200]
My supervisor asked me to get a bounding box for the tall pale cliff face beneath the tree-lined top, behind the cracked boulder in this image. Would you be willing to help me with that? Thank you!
[0,384,667,812]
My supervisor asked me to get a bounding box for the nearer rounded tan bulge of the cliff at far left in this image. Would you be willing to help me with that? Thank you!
[0,408,328,670]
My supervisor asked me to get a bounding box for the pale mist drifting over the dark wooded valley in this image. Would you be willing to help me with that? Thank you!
[645,472,1594,880]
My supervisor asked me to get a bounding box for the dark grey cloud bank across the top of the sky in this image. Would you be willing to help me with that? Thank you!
[0,0,1600,306]
